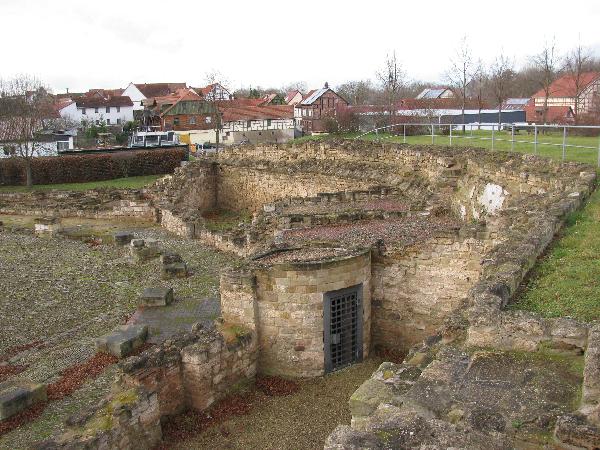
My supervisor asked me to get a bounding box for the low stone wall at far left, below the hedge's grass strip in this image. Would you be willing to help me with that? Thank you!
[0,189,156,221]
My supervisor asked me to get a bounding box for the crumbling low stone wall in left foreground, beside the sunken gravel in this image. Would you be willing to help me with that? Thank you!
[38,325,257,450]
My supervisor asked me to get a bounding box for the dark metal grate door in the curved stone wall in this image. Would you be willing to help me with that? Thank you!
[323,285,363,372]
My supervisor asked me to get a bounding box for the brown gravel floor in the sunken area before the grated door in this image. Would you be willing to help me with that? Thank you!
[172,358,382,450]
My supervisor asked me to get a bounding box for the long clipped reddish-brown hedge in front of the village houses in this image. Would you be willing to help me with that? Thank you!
[0,148,187,186]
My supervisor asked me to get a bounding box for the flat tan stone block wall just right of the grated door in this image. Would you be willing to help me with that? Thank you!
[372,230,491,352]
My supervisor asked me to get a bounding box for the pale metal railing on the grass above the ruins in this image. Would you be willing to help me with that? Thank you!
[355,122,600,167]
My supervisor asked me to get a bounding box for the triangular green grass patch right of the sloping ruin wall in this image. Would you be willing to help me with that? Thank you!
[509,190,600,321]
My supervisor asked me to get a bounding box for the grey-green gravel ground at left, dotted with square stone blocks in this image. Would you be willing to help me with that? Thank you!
[0,216,235,449]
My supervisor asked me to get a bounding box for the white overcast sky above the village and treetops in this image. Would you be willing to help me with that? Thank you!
[0,0,600,92]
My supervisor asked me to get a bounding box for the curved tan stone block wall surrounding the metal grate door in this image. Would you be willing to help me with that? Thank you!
[221,250,371,377]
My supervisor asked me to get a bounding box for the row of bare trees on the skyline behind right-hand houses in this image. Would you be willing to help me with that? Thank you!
[236,36,600,127]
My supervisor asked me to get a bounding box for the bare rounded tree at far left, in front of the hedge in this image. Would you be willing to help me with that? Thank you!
[0,75,54,186]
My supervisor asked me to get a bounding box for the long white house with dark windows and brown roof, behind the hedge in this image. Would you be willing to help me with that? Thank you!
[58,95,133,125]
